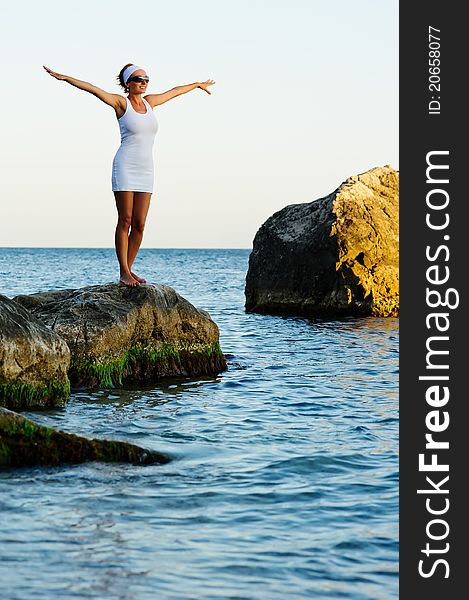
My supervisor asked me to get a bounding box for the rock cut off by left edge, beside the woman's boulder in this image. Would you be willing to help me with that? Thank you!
[0,295,70,408]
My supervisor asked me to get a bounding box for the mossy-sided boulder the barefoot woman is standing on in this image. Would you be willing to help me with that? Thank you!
[14,283,226,387]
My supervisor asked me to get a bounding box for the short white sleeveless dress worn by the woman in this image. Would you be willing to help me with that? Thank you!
[112,98,158,192]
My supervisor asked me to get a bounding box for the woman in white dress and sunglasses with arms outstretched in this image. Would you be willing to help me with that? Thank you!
[43,63,215,287]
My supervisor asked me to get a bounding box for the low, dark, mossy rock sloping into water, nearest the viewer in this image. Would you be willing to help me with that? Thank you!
[0,408,170,469]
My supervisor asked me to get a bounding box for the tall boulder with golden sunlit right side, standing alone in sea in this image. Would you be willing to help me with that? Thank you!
[245,165,399,316]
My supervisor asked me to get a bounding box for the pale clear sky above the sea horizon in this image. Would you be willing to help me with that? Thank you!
[0,0,399,248]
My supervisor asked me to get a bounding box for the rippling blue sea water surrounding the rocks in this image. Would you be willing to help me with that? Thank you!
[0,248,398,600]
